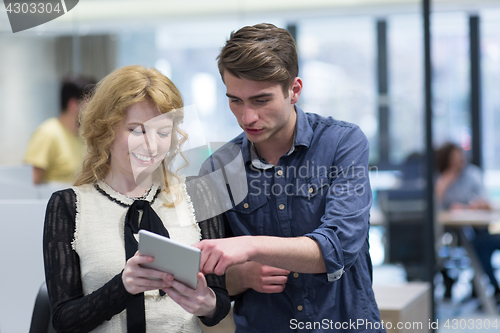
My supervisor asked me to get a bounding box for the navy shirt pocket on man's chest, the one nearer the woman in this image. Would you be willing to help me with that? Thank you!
[228,193,269,236]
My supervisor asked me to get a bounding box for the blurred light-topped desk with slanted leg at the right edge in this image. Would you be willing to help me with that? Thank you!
[437,209,500,314]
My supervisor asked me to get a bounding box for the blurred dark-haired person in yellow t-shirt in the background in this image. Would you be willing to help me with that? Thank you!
[24,78,95,184]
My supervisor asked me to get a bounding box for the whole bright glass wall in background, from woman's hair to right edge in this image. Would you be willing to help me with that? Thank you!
[103,11,500,201]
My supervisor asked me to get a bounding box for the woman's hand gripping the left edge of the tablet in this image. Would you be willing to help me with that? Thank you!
[122,252,171,295]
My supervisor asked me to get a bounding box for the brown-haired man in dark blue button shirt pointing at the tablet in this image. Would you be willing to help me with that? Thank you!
[196,24,384,332]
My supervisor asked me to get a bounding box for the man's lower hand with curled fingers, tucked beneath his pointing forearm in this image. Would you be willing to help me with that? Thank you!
[226,261,290,296]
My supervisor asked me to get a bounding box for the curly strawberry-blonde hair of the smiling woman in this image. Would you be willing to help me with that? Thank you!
[74,66,187,202]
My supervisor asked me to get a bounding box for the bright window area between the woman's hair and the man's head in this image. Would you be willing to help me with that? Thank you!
[155,20,241,142]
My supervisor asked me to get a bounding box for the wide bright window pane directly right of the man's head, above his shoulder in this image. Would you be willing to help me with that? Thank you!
[297,16,378,161]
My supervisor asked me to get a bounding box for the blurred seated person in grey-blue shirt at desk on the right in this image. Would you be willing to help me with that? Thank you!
[434,143,500,295]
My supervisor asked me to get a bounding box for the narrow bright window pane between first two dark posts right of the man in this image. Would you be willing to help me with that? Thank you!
[387,13,425,165]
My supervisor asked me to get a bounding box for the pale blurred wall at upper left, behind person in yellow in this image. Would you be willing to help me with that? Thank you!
[0,33,59,164]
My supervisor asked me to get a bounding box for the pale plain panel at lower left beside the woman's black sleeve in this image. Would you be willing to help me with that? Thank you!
[0,200,47,333]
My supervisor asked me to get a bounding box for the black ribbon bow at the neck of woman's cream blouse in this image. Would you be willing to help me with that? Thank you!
[125,200,170,332]
